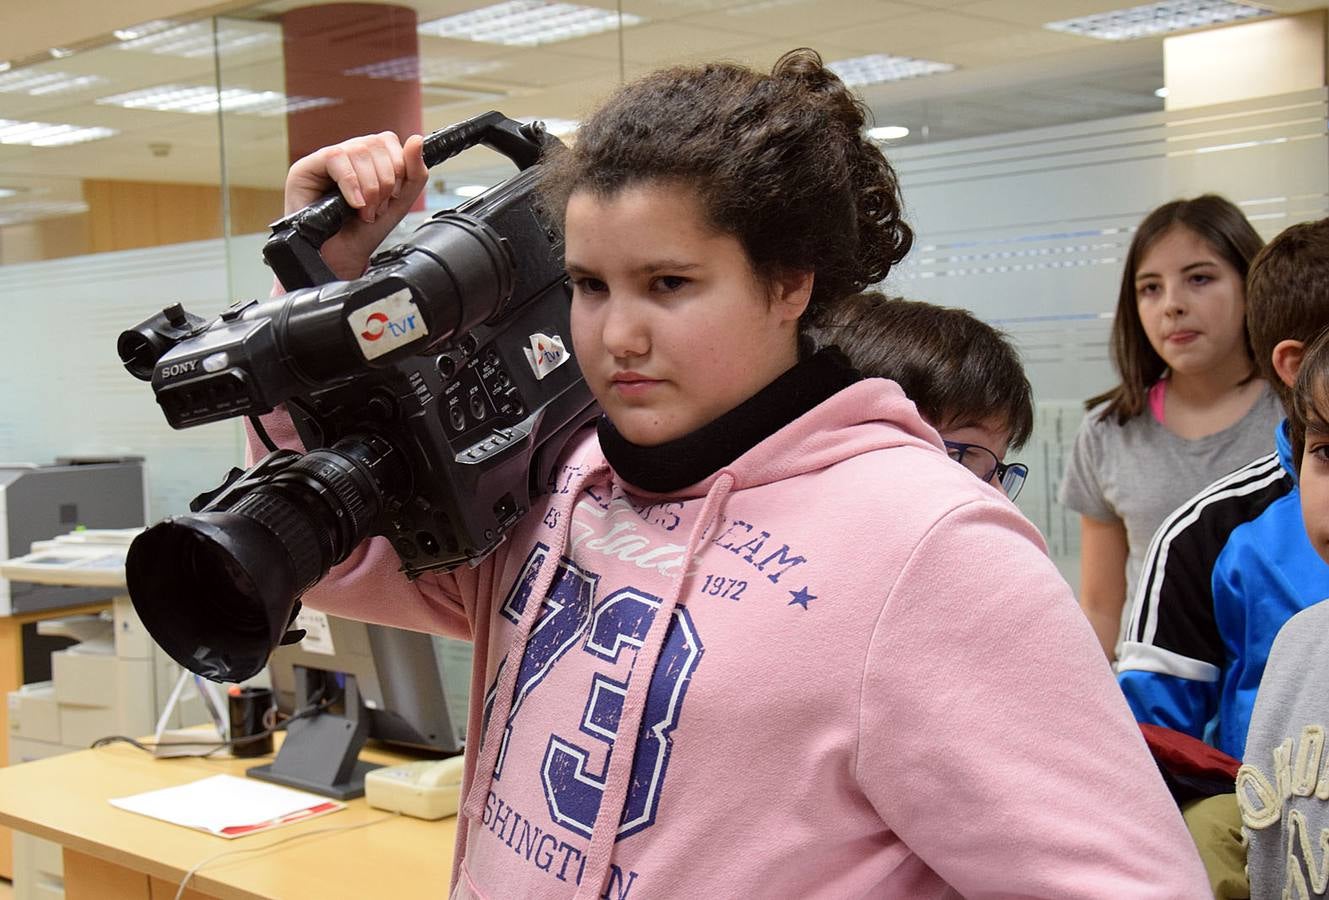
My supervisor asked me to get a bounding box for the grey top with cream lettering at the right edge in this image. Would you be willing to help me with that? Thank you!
[1237,601,1329,900]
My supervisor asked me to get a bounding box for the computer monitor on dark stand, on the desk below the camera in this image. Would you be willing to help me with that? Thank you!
[249,610,472,799]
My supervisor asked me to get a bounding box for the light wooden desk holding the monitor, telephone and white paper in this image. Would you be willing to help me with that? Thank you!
[0,744,457,900]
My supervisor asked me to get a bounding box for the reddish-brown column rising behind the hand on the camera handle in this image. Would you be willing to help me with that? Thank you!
[282,3,421,162]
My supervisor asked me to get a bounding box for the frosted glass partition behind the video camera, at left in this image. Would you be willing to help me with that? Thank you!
[0,235,271,520]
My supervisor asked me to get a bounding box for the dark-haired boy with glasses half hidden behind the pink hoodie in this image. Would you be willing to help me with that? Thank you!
[812,291,1034,500]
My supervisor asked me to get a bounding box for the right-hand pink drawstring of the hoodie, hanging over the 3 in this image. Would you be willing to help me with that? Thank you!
[574,472,734,900]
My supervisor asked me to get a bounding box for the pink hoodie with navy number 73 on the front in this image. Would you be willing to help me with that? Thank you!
[251,379,1209,900]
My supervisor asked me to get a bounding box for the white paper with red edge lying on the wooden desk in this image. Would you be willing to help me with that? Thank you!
[110,775,346,838]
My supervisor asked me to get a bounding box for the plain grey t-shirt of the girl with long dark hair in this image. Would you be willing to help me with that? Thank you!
[1061,386,1282,647]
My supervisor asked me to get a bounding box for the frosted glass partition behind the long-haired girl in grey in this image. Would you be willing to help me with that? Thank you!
[886,89,1329,584]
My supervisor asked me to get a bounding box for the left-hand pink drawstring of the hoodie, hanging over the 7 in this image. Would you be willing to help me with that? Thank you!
[461,465,609,827]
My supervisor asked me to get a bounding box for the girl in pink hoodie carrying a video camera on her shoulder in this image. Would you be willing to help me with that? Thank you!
[259,51,1207,897]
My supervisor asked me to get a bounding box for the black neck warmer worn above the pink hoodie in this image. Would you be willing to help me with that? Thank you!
[597,347,863,493]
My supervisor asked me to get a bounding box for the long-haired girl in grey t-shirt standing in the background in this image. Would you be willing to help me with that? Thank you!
[1061,194,1282,659]
